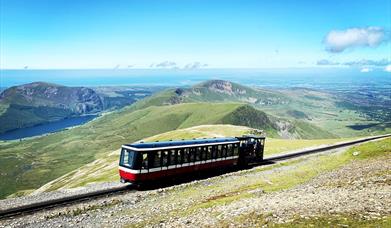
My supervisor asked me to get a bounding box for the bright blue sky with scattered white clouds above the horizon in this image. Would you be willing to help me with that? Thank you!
[0,0,391,70]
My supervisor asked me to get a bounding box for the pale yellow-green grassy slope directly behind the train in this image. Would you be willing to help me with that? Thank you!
[31,125,356,192]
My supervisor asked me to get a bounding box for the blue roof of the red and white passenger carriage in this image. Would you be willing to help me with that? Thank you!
[123,137,239,150]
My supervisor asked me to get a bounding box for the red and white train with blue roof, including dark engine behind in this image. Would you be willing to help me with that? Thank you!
[119,135,265,185]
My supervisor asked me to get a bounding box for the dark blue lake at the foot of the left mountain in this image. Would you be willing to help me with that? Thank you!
[0,115,98,140]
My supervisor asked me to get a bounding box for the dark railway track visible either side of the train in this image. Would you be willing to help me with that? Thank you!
[0,134,391,219]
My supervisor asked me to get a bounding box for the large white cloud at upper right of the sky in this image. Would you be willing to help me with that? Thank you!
[324,27,387,52]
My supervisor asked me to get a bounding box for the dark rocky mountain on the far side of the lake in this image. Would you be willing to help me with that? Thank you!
[0,82,104,133]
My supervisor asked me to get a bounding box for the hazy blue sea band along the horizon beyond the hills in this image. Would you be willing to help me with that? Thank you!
[0,67,391,88]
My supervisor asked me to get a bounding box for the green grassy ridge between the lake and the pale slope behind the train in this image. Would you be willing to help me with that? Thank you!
[0,103,280,197]
